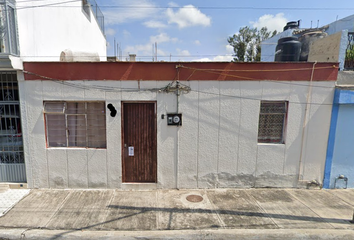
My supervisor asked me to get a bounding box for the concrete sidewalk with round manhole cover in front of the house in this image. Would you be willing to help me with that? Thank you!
[0,189,354,239]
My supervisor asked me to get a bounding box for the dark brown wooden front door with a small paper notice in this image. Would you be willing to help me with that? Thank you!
[122,102,157,183]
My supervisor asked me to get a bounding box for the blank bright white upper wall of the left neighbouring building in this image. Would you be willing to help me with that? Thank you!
[17,0,107,61]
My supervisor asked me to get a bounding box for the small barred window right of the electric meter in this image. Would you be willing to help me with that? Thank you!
[258,101,288,144]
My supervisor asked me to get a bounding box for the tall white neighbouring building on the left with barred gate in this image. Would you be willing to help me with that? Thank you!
[0,0,106,182]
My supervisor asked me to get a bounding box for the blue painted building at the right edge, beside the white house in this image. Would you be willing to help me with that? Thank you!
[323,72,354,188]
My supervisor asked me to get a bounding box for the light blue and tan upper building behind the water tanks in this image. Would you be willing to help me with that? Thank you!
[261,15,354,70]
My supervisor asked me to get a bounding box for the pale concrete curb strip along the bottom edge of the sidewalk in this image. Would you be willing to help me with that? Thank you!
[0,229,354,240]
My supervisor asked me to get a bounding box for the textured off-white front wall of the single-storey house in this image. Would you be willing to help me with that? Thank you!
[19,76,334,188]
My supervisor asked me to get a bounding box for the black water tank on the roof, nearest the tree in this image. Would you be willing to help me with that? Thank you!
[274,37,301,62]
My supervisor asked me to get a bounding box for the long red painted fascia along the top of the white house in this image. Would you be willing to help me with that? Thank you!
[24,62,338,81]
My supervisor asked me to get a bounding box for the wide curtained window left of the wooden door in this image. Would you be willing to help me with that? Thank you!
[44,102,106,148]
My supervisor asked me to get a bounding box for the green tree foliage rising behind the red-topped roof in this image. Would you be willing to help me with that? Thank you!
[227,26,277,62]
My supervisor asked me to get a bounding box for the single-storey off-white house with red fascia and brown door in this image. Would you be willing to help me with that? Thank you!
[19,62,338,189]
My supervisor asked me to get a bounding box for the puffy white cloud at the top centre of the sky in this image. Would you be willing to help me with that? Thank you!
[166,5,211,28]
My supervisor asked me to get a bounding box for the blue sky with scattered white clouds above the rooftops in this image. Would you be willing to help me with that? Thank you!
[96,0,354,61]
